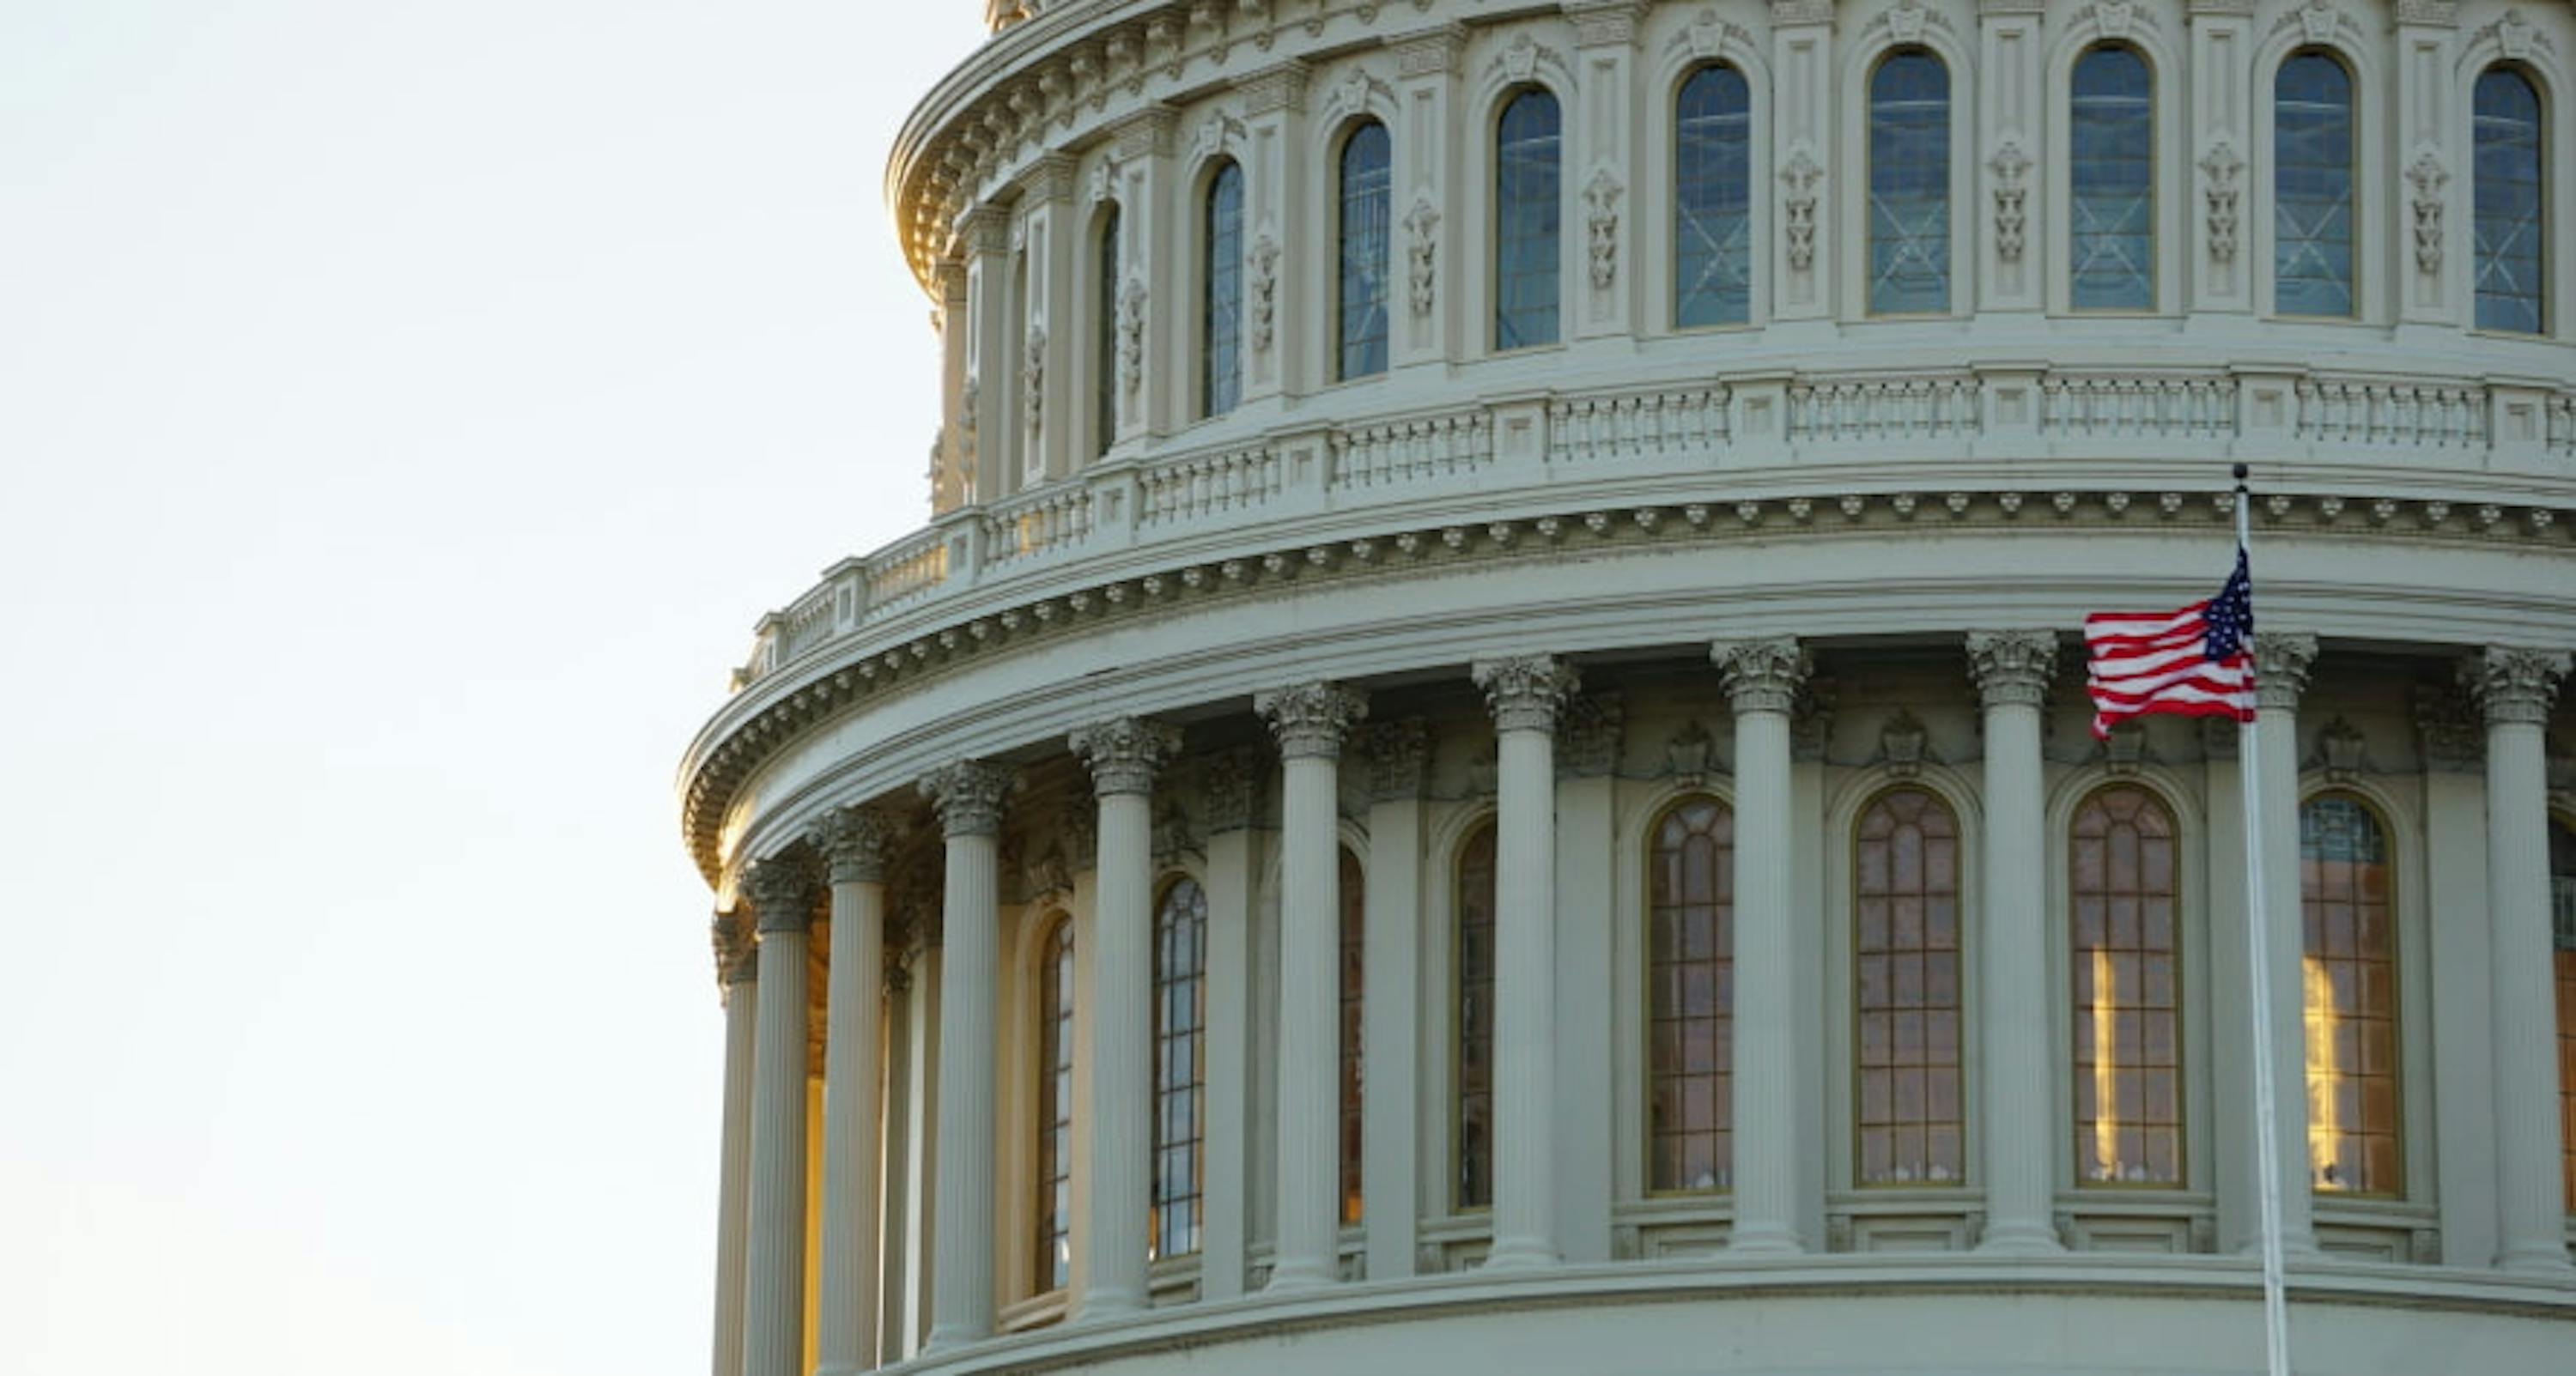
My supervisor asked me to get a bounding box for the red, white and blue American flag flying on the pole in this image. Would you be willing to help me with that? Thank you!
[2084,546,2254,740]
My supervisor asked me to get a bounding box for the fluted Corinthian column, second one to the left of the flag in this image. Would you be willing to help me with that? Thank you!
[1708,636,1811,1252]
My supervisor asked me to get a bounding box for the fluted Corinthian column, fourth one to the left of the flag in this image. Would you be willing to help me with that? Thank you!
[1252,682,1368,1291]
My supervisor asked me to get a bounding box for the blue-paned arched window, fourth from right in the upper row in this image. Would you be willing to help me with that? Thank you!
[1870,49,1950,314]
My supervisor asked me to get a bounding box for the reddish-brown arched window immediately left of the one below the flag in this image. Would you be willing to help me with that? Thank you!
[1852,789,1968,1185]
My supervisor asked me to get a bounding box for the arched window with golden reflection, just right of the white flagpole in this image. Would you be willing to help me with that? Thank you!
[2298,794,2406,1196]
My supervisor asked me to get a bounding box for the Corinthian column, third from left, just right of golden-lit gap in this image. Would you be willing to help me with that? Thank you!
[814,807,891,1376]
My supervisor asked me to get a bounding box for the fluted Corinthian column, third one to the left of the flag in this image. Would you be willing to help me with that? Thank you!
[1471,654,1577,1268]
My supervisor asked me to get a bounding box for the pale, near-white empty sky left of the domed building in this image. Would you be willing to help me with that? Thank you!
[0,0,979,1376]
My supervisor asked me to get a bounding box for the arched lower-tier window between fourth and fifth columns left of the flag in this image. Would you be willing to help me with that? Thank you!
[1146,879,1208,1258]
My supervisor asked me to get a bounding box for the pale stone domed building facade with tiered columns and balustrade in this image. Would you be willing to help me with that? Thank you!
[683,0,2576,1376]
